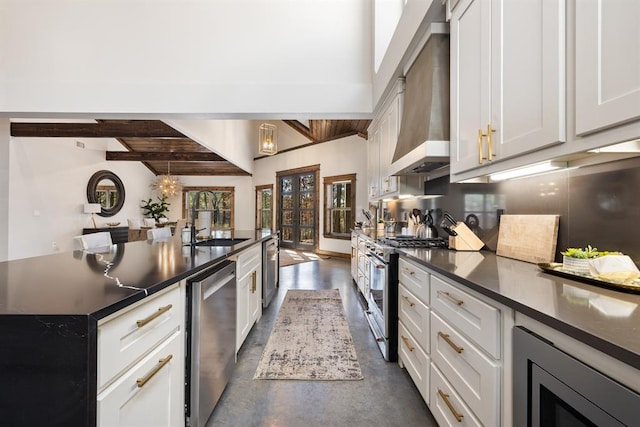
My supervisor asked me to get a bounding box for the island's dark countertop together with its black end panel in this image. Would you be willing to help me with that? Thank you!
[0,230,274,426]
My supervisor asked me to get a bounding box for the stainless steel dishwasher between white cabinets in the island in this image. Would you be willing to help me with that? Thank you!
[185,261,237,427]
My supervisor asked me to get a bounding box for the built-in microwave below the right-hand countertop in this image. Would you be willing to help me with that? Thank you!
[513,326,640,427]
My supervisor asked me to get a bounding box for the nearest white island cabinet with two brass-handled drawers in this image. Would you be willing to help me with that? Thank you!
[97,282,186,427]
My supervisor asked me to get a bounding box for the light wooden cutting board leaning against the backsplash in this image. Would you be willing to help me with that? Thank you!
[496,215,560,263]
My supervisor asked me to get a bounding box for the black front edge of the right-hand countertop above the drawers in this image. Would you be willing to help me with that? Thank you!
[398,249,640,369]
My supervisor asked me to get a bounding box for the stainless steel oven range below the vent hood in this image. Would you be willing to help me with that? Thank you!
[365,243,398,362]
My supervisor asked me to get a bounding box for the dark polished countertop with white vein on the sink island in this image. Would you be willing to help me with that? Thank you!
[0,230,274,319]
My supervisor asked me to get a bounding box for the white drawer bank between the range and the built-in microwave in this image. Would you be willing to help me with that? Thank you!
[398,258,514,426]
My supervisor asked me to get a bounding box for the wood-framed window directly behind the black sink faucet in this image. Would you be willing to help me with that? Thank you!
[182,187,234,230]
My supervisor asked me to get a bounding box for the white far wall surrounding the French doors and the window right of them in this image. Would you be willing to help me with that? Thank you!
[253,136,368,253]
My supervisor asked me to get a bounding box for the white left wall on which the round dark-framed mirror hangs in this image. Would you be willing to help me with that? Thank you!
[8,137,154,259]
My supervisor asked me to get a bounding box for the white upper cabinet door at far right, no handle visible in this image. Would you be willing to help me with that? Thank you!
[575,0,640,135]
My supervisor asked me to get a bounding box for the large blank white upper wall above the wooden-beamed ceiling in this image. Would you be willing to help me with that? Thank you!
[0,0,373,119]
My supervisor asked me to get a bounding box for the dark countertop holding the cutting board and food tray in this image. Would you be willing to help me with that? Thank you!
[400,248,640,369]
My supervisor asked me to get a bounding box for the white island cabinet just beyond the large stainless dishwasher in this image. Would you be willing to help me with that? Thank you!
[234,245,262,353]
